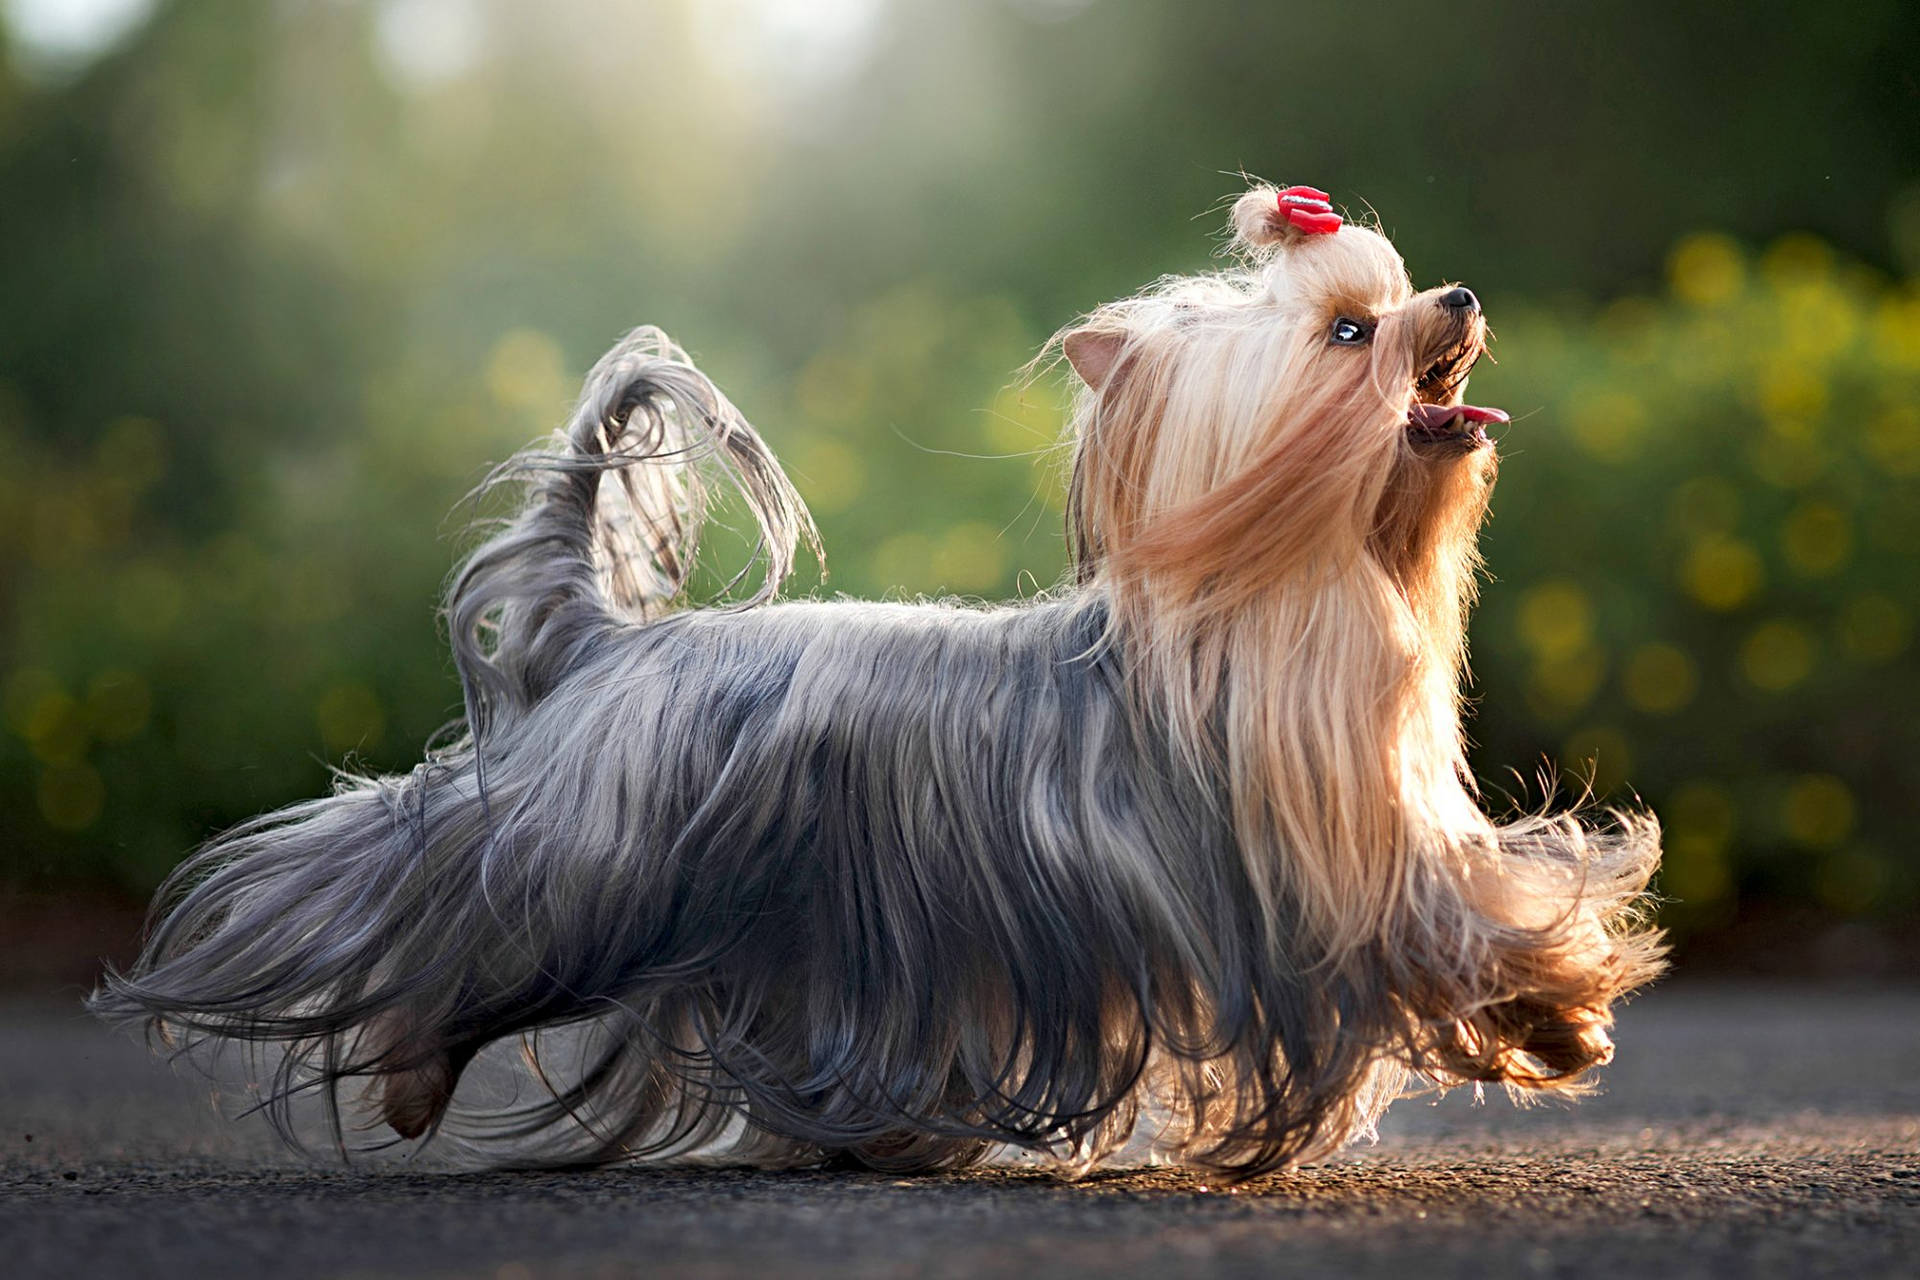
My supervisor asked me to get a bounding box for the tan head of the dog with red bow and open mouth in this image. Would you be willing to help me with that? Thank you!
[1062,186,1505,621]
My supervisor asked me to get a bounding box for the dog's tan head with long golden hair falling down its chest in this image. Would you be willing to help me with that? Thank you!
[1060,186,1505,948]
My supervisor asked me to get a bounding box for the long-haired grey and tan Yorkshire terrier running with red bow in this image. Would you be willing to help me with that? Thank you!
[92,186,1661,1178]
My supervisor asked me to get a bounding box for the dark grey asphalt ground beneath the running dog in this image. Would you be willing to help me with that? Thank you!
[0,983,1920,1280]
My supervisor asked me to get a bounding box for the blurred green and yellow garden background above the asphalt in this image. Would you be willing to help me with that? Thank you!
[0,0,1920,981]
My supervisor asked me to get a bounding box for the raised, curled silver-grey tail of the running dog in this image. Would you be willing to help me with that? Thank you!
[447,326,826,741]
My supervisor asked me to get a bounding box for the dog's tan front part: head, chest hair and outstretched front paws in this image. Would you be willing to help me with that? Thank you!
[1060,186,1657,1088]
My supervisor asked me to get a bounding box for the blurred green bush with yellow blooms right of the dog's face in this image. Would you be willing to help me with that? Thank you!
[1475,234,1920,925]
